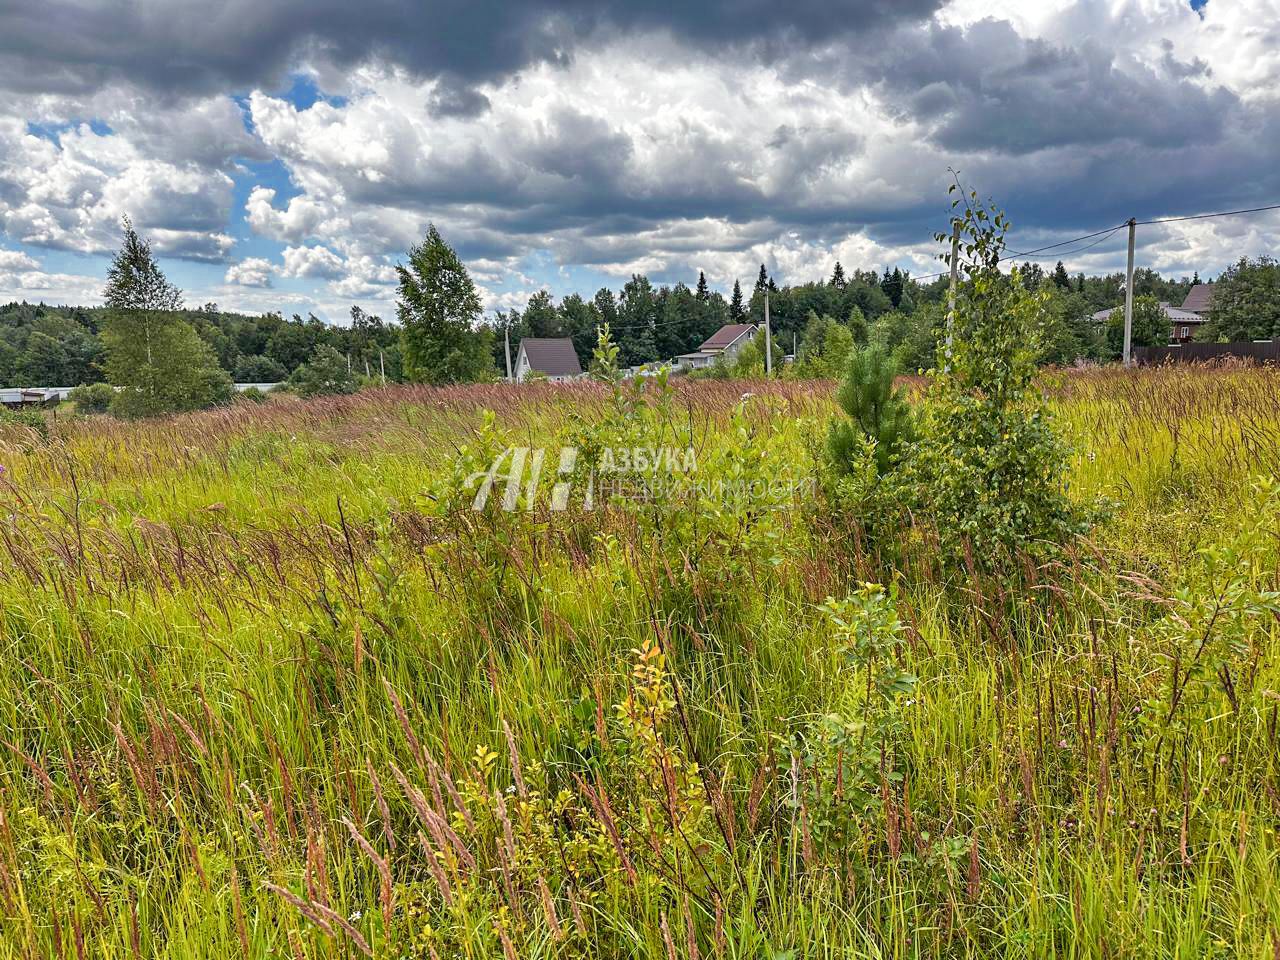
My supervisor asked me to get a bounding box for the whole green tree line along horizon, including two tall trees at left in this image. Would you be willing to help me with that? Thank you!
[0,220,1280,415]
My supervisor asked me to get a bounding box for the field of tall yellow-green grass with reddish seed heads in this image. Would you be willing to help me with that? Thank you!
[0,367,1280,960]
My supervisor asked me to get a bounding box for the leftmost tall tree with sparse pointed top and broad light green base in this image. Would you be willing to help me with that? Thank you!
[101,218,232,417]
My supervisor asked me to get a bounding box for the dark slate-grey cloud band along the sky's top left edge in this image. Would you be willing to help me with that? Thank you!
[0,0,941,98]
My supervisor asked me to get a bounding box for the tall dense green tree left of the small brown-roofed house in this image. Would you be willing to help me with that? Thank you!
[396,224,494,384]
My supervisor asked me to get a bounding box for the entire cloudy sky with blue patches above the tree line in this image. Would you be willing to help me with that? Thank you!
[0,0,1280,323]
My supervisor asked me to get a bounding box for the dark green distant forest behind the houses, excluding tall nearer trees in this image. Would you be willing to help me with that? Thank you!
[0,264,1193,387]
